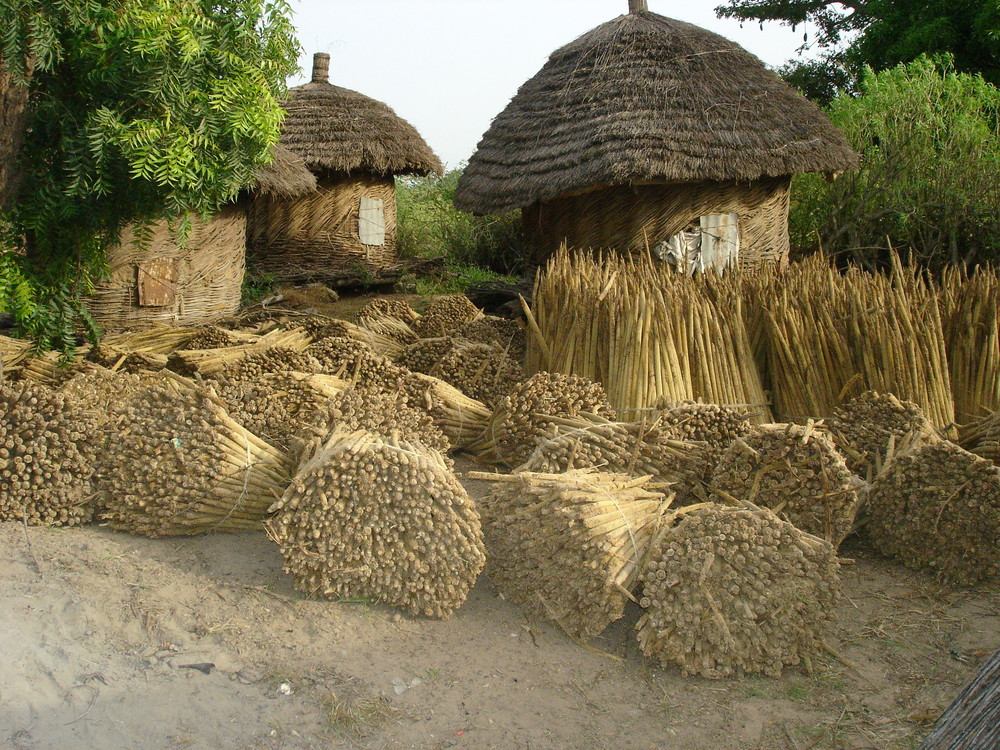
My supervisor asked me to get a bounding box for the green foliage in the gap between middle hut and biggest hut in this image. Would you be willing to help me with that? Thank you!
[396,169,524,273]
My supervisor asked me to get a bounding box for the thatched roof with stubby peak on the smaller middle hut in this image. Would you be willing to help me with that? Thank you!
[281,53,442,175]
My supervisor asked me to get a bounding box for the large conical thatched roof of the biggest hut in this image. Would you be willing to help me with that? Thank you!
[455,4,858,213]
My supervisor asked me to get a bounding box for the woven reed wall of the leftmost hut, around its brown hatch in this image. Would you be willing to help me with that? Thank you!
[87,205,246,327]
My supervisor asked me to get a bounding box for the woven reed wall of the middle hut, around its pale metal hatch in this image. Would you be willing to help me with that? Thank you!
[247,175,397,281]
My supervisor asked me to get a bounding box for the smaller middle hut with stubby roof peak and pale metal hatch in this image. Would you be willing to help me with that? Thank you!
[248,53,441,281]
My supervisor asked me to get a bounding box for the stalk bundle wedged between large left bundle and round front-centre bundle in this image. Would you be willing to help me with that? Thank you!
[213,372,350,451]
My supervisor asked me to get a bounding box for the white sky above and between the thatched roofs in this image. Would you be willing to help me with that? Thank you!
[289,0,803,168]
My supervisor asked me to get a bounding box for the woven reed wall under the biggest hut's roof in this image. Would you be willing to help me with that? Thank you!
[522,176,791,268]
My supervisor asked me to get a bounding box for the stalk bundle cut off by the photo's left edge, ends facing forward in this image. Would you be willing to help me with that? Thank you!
[0,383,100,526]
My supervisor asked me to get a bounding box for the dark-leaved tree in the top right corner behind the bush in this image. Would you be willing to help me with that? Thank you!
[715,0,1000,103]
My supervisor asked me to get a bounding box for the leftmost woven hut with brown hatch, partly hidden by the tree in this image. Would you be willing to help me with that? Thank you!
[87,146,316,328]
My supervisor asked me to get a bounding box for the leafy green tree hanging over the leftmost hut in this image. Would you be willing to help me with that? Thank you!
[0,0,298,348]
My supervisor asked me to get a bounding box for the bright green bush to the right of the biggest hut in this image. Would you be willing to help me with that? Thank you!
[790,58,1000,267]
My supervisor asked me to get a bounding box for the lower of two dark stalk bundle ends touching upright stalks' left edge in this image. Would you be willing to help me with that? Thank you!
[429,339,524,408]
